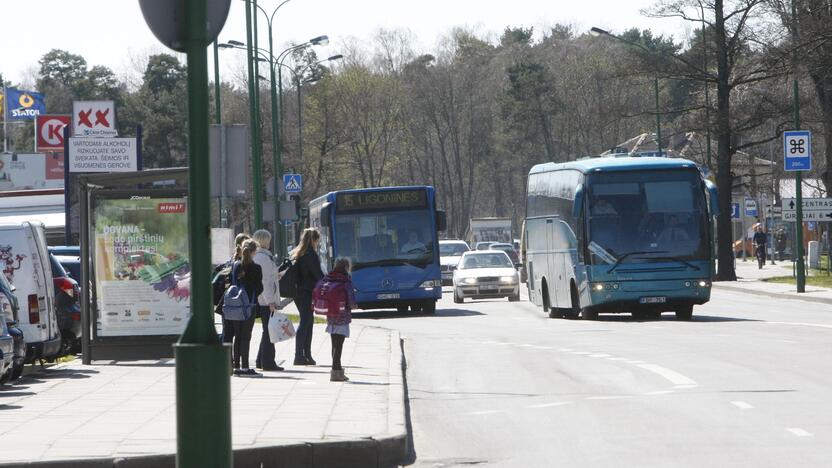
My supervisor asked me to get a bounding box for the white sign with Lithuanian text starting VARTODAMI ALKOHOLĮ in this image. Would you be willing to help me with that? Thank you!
[69,138,138,172]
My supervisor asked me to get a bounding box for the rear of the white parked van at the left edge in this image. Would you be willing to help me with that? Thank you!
[0,227,49,343]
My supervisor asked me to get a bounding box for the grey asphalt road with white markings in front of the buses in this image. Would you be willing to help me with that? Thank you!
[356,288,832,467]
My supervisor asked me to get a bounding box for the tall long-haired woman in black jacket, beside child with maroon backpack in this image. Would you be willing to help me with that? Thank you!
[292,228,324,366]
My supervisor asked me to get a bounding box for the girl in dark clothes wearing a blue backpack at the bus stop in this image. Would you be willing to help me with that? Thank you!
[223,239,263,376]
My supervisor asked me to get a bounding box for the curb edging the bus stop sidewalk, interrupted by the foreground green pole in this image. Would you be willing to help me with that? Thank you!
[0,330,408,468]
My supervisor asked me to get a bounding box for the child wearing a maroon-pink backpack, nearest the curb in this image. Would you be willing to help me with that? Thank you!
[313,257,355,382]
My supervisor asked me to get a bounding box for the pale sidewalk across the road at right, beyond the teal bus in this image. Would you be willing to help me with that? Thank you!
[713,258,832,304]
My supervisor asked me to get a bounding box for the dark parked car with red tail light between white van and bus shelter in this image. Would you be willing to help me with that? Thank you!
[49,253,81,355]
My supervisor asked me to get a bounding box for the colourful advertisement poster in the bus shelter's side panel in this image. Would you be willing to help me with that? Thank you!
[94,197,191,337]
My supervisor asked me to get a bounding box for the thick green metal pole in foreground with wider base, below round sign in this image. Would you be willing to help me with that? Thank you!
[174,0,233,468]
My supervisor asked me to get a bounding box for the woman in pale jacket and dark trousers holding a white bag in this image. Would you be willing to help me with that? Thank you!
[251,229,283,371]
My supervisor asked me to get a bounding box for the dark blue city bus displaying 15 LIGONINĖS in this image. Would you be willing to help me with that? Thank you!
[309,186,446,314]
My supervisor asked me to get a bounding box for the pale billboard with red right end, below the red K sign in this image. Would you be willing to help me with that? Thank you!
[0,153,64,192]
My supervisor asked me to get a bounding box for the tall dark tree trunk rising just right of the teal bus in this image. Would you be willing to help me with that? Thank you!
[714,0,737,281]
